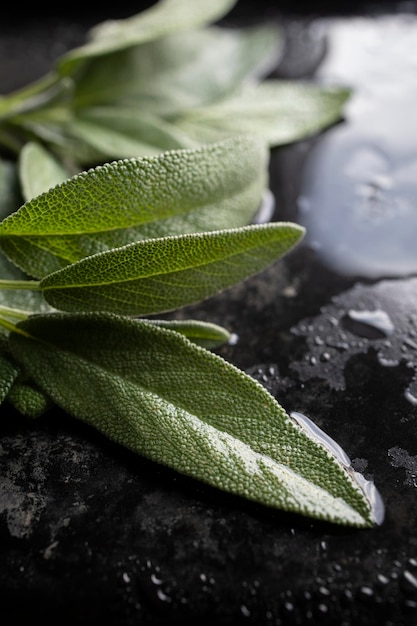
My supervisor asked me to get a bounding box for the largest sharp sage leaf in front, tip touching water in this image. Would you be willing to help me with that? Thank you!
[10,314,375,527]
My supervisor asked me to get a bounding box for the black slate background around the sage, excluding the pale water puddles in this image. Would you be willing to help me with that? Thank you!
[0,2,417,626]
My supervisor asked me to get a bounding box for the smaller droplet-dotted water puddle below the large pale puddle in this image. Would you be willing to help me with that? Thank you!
[290,278,417,406]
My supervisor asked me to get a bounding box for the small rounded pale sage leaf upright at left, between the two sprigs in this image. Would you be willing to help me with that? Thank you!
[19,141,71,200]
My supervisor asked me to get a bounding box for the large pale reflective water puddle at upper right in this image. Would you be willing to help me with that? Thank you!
[297,15,417,280]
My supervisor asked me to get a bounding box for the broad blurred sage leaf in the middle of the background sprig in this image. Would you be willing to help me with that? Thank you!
[73,24,283,114]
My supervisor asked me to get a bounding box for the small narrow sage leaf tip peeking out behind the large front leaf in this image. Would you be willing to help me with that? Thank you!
[141,319,233,349]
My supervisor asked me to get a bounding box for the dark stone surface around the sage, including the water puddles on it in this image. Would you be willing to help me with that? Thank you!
[0,3,417,626]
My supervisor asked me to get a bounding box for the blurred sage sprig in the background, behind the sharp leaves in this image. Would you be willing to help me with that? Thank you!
[0,0,350,166]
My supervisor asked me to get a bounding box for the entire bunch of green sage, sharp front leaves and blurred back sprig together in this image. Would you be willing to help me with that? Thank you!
[0,0,382,527]
